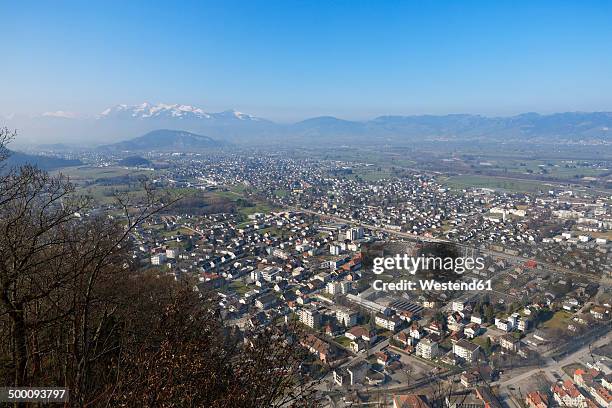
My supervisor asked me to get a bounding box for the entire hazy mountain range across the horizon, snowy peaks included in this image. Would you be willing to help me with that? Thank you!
[6,103,612,145]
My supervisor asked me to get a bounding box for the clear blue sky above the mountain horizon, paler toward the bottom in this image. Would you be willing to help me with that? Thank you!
[0,0,612,121]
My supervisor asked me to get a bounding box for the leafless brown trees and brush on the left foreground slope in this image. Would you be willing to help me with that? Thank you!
[0,131,316,407]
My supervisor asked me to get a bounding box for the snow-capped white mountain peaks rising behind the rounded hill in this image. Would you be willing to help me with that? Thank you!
[97,102,260,121]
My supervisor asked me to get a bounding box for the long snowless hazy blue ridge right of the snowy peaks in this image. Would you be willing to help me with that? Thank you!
[290,113,612,142]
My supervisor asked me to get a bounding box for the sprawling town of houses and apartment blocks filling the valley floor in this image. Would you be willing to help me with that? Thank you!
[50,152,612,408]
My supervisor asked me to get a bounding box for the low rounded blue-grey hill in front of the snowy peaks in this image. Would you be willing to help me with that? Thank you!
[100,129,226,151]
